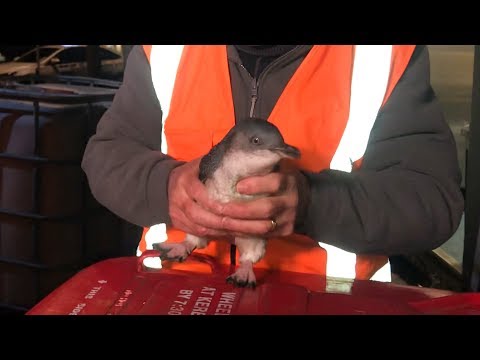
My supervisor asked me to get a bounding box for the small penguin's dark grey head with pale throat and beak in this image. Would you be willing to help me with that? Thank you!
[225,118,300,175]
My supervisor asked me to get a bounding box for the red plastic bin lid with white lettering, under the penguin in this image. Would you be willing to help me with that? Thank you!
[27,251,480,315]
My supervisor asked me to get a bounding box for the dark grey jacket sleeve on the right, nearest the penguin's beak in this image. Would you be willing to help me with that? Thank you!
[299,46,464,255]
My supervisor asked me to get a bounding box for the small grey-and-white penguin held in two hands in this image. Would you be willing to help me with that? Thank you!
[155,118,300,287]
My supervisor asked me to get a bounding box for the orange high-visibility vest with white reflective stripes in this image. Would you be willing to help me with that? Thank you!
[138,45,415,279]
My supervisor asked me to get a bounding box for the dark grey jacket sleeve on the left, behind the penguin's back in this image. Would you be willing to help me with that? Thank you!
[82,46,181,226]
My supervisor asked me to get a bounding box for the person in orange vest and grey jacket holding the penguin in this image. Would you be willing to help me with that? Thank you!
[82,45,464,286]
